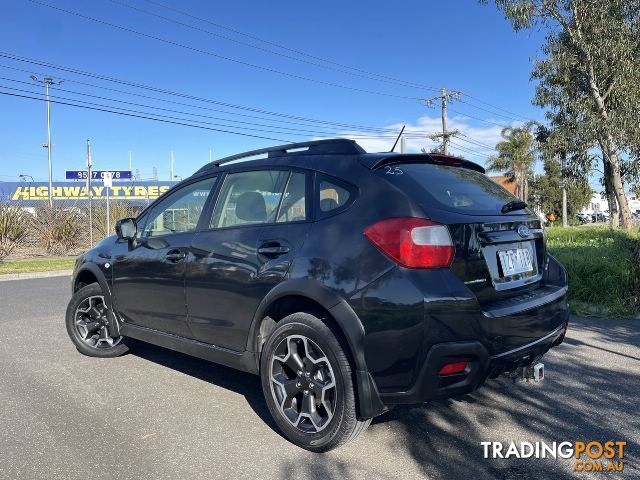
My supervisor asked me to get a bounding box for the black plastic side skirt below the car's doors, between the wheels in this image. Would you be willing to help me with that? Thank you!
[120,323,258,374]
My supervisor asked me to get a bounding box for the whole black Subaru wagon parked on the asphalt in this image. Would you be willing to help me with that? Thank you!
[66,139,568,452]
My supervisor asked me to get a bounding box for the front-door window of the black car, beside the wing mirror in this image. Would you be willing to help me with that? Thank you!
[144,178,216,237]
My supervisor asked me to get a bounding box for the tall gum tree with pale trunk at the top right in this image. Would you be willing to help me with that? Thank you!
[481,0,640,228]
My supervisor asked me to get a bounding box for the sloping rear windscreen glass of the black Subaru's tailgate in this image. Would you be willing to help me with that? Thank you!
[379,163,522,215]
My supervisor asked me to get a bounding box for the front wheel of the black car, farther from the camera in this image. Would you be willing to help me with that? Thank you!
[65,283,129,358]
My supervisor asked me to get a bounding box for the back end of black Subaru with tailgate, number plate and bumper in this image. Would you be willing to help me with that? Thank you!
[358,155,568,403]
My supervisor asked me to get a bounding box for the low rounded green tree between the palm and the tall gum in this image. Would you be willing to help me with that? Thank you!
[530,154,593,219]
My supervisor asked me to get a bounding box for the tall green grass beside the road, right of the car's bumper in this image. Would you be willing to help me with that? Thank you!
[547,226,640,318]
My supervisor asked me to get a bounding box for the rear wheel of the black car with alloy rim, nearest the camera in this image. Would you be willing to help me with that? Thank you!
[260,313,371,452]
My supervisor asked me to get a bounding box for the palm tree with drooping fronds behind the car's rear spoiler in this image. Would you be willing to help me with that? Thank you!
[485,122,536,201]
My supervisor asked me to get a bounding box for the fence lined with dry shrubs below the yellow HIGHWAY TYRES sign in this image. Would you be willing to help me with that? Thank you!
[0,198,145,260]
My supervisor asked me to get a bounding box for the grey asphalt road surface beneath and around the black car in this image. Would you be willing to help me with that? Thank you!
[0,278,640,480]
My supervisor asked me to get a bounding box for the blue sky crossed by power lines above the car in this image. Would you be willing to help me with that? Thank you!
[0,0,542,181]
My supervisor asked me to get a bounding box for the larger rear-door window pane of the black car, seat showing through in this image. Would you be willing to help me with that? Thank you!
[211,170,289,228]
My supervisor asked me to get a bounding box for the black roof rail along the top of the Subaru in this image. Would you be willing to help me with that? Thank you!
[198,138,367,172]
